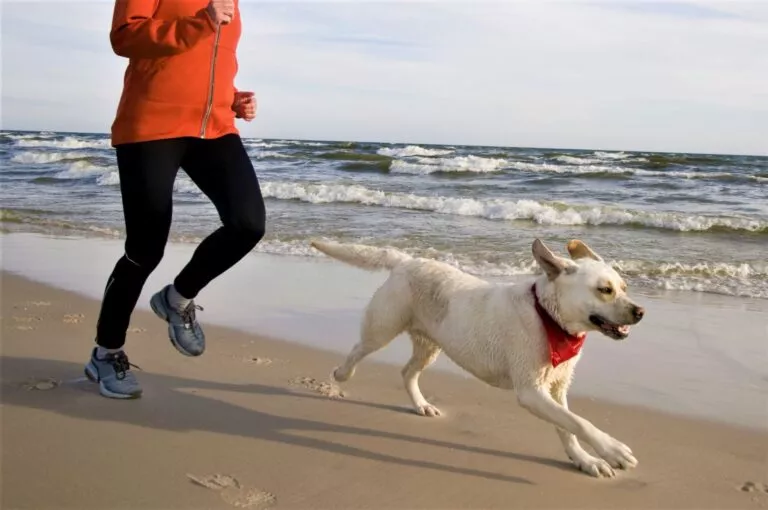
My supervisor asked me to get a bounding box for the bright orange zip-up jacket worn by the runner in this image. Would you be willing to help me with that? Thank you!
[109,0,241,145]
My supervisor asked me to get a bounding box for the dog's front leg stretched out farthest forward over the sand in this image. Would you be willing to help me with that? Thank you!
[517,385,637,476]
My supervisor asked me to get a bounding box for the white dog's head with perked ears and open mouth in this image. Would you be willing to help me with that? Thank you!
[533,239,645,340]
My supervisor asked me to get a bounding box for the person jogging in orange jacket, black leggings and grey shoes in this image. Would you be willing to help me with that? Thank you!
[85,0,266,399]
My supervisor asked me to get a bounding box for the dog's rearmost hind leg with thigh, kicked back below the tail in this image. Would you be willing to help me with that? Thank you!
[333,279,410,382]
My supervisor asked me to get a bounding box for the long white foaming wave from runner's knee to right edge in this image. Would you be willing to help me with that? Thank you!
[262,181,768,233]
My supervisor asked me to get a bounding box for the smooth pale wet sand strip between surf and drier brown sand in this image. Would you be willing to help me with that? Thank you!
[0,234,768,430]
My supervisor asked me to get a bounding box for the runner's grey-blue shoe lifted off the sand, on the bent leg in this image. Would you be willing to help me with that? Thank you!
[149,285,205,356]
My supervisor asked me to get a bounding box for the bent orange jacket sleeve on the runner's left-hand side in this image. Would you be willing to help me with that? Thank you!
[109,0,216,58]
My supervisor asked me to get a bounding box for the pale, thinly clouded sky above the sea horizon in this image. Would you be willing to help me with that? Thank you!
[0,0,768,155]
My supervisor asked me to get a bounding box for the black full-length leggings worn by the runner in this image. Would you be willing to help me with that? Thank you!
[96,134,266,349]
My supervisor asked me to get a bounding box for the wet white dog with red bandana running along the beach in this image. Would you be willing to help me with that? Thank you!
[312,239,645,477]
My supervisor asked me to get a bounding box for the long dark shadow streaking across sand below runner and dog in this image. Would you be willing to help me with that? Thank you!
[0,356,574,485]
